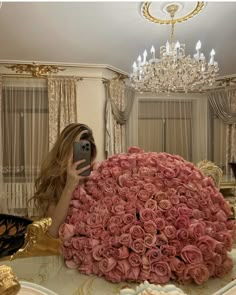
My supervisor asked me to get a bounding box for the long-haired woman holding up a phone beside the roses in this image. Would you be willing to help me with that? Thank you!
[33,123,97,238]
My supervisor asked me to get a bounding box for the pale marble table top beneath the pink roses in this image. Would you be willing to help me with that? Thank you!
[0,248,236,295]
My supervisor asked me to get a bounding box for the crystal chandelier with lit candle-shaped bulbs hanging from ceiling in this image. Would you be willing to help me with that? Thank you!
[130,4,219,93]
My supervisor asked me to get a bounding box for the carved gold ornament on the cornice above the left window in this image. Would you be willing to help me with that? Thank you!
[6,62,65,77]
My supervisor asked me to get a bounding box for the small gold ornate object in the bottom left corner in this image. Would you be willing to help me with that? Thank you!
[0,265,20,295]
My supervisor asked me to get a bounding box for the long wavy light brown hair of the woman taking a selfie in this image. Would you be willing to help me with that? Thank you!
[33,123,97,216]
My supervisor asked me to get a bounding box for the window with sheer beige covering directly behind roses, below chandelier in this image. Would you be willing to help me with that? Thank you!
[138,98,193,161]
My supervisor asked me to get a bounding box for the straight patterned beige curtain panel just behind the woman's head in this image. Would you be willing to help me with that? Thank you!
[48,77,77,149]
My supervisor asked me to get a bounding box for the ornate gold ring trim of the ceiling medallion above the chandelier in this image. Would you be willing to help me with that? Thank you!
[141,1,205,25]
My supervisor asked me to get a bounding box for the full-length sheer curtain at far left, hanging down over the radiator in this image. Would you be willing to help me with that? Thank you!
[0,77,48,216]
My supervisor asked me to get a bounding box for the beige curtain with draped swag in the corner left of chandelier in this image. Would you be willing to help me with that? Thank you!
[105,79,135,157]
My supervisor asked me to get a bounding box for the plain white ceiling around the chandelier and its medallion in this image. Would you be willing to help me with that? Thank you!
[0,2,236,76]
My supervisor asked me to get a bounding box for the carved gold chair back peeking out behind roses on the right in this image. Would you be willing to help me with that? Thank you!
[197,160,223,189]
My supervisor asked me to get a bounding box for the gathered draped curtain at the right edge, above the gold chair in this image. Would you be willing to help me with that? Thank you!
[208,89,236,172]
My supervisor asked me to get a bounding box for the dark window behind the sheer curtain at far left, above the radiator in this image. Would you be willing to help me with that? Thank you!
[2,79,48,182]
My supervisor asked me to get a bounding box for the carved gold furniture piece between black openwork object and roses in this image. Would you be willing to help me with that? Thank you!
[10,218,60,260]
